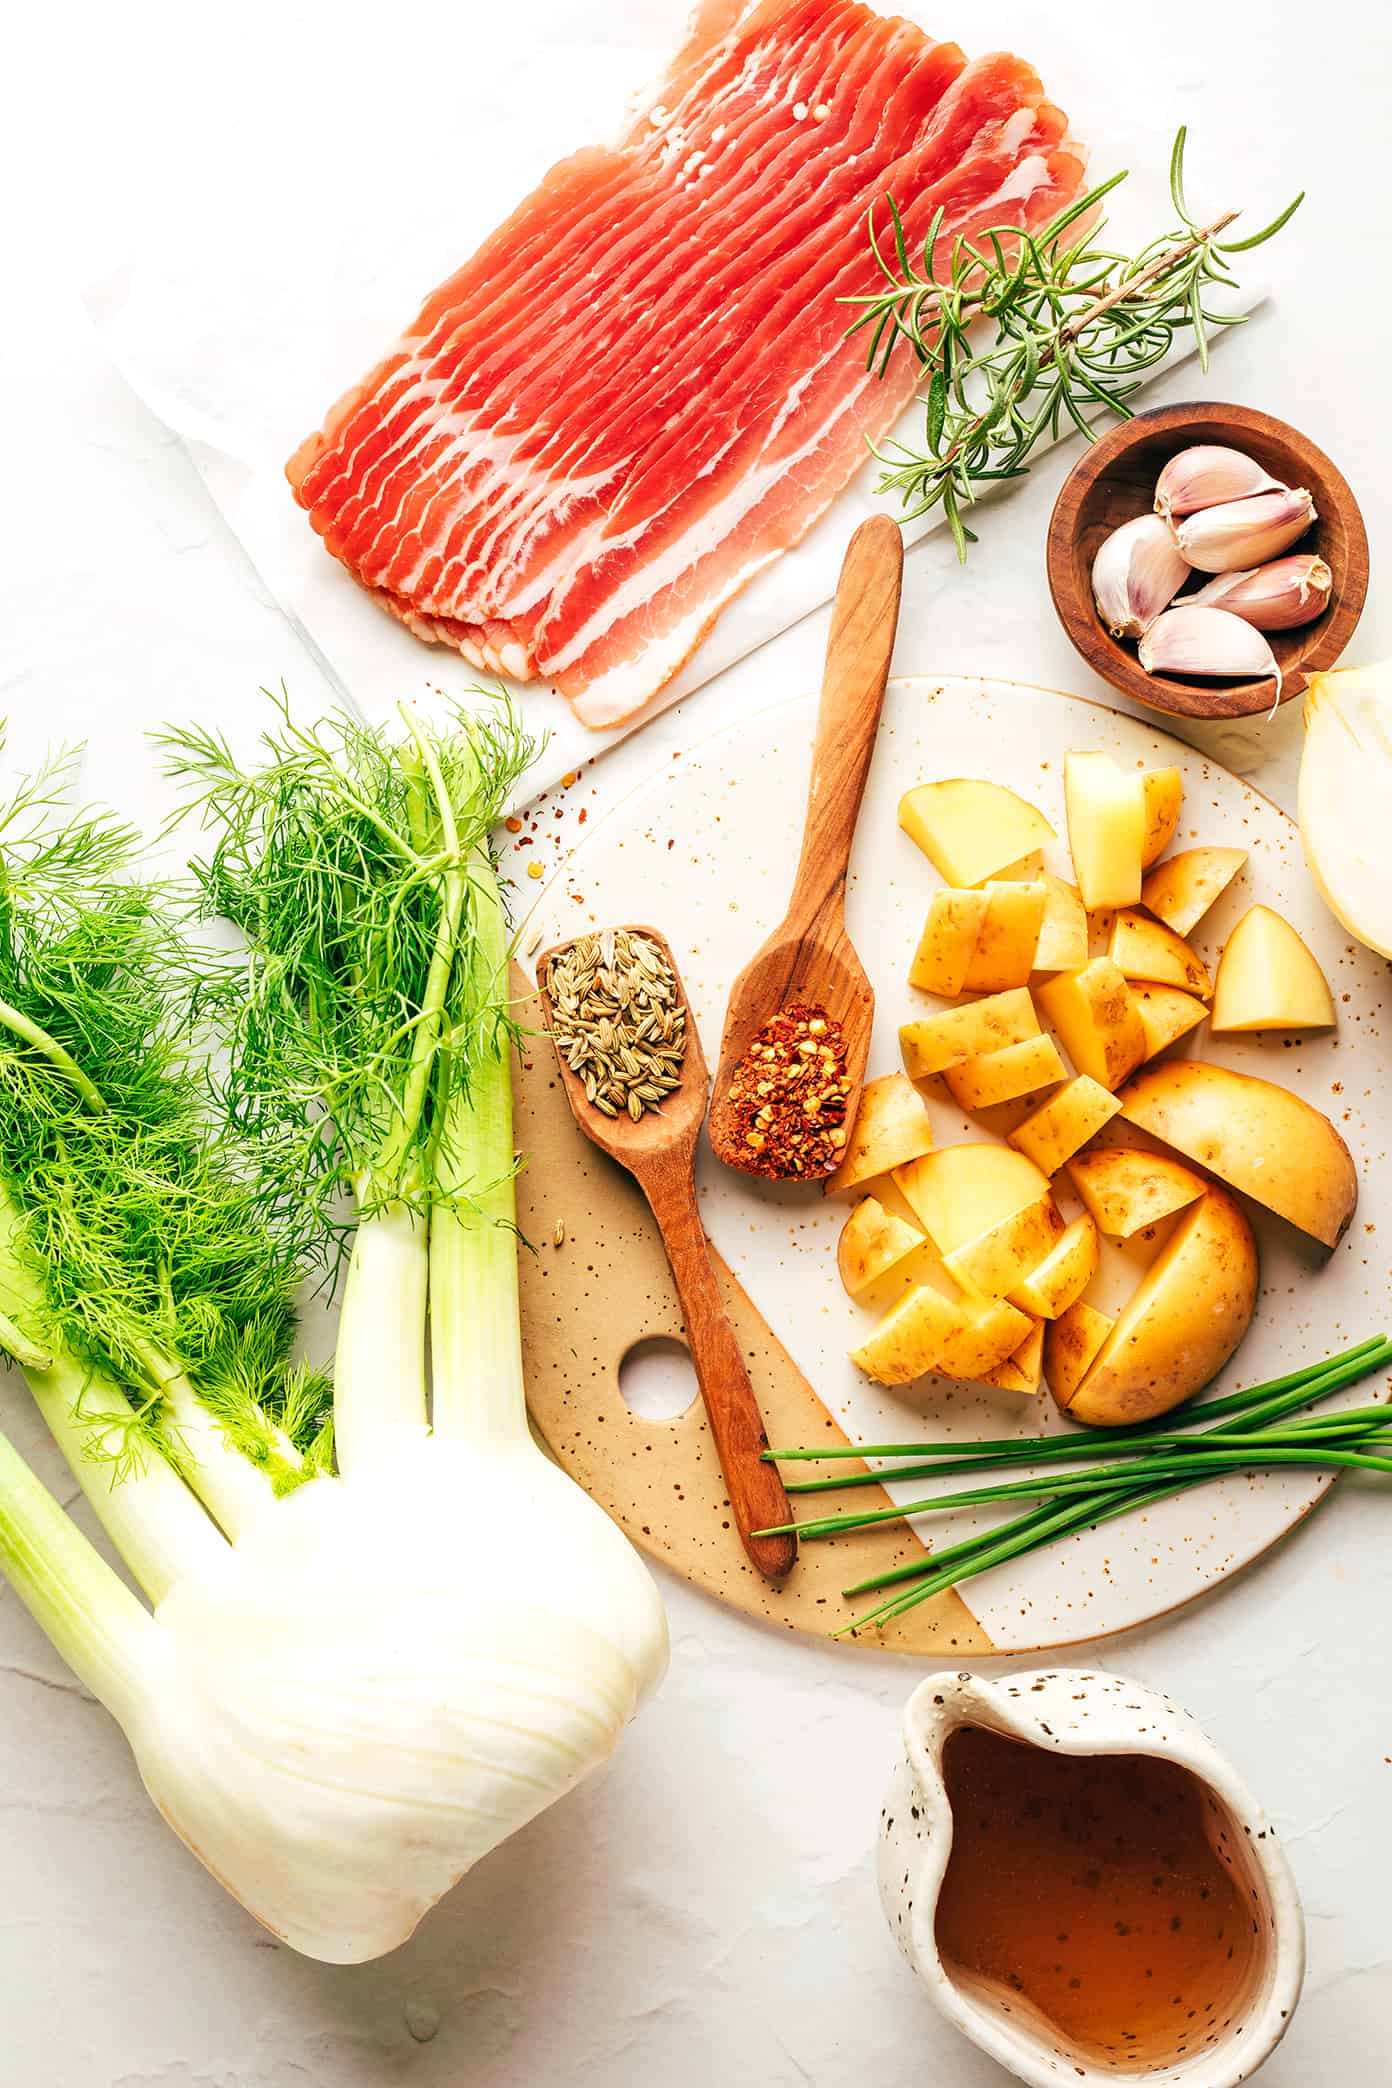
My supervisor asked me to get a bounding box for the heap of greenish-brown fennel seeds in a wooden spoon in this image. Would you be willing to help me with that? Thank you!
[547,929,687,1123]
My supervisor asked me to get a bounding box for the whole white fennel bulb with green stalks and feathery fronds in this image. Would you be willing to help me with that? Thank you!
[0,720,666,1963]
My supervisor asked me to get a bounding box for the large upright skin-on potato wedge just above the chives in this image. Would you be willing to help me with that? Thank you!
[1054,1184,1258,1428]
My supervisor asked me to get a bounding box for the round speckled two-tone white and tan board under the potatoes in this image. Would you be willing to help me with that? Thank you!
[518,679,1392,1654]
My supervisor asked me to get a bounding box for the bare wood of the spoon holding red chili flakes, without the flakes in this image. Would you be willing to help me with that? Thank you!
[710,516,904,1180]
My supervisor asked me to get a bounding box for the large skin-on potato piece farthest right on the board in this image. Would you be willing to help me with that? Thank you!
[1121,1059,1359,1247]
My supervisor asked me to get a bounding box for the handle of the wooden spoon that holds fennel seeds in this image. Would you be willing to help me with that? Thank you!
[643,1176,797,1581]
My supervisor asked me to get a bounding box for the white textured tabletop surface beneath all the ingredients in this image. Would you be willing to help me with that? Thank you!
[0,0,1392,2088]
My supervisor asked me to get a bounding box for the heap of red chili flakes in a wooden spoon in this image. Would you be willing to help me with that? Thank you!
[724,1000,851,1182]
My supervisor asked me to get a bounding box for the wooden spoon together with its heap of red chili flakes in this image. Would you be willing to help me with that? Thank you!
[707,516,904,1182]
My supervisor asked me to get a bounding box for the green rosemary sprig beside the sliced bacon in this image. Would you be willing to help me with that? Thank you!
[845,129,1304,562]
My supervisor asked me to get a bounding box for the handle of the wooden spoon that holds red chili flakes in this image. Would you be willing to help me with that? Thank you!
[789,516,904,921]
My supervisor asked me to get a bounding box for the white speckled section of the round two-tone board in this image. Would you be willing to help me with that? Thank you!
[515,679,1388,1652]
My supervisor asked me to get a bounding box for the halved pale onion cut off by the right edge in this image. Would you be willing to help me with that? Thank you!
[1300,662,1392,956]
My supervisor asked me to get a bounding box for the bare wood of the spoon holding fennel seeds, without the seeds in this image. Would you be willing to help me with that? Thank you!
[536,927,797,1581]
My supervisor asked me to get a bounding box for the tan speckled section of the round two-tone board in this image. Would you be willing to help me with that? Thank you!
[515,981,993,1658]
